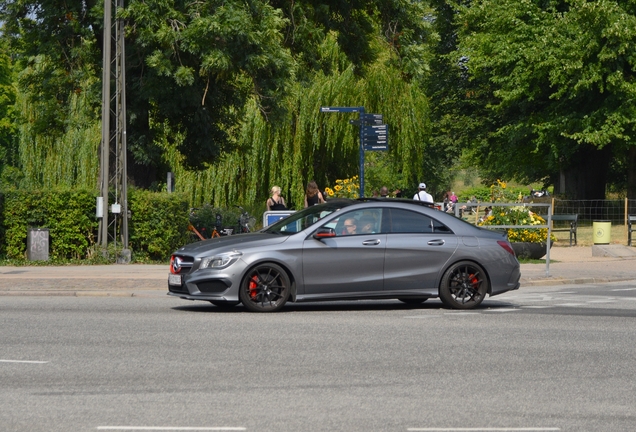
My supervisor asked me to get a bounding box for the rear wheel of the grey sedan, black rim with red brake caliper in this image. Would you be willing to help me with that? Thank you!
[439,261,489,309]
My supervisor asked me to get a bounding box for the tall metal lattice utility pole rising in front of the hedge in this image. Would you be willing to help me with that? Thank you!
[97,0,130,263]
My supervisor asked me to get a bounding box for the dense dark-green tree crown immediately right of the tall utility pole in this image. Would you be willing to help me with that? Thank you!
[120,0,295,172]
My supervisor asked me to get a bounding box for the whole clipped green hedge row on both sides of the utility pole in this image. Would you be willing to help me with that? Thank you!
[0,190,189,261]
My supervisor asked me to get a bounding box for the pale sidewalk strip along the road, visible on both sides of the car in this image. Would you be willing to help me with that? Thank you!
[0,245,636,298]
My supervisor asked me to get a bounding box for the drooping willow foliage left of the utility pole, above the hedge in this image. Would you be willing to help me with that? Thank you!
[15,55,101,189]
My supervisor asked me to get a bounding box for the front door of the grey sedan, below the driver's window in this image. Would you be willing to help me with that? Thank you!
[299,208,386,297]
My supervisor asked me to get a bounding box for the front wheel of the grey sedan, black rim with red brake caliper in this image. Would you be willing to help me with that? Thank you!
[239,263,291,312]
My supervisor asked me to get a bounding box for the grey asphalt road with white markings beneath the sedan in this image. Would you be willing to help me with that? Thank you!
[0,282,636,432]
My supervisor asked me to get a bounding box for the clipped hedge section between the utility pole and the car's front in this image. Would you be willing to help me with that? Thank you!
[128,189,189,262]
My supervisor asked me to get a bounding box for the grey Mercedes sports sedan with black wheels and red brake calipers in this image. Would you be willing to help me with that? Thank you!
[168,198,521,312]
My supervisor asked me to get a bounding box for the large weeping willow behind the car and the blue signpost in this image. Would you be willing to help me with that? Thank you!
[163,36,436,211]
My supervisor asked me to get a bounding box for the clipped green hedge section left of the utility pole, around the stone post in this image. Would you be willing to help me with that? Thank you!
[0,190,97,260]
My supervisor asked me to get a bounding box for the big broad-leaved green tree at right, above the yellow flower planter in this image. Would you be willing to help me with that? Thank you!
[456,0,636,199]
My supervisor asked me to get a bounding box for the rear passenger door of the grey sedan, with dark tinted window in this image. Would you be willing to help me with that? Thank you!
[384,208,457,292]
